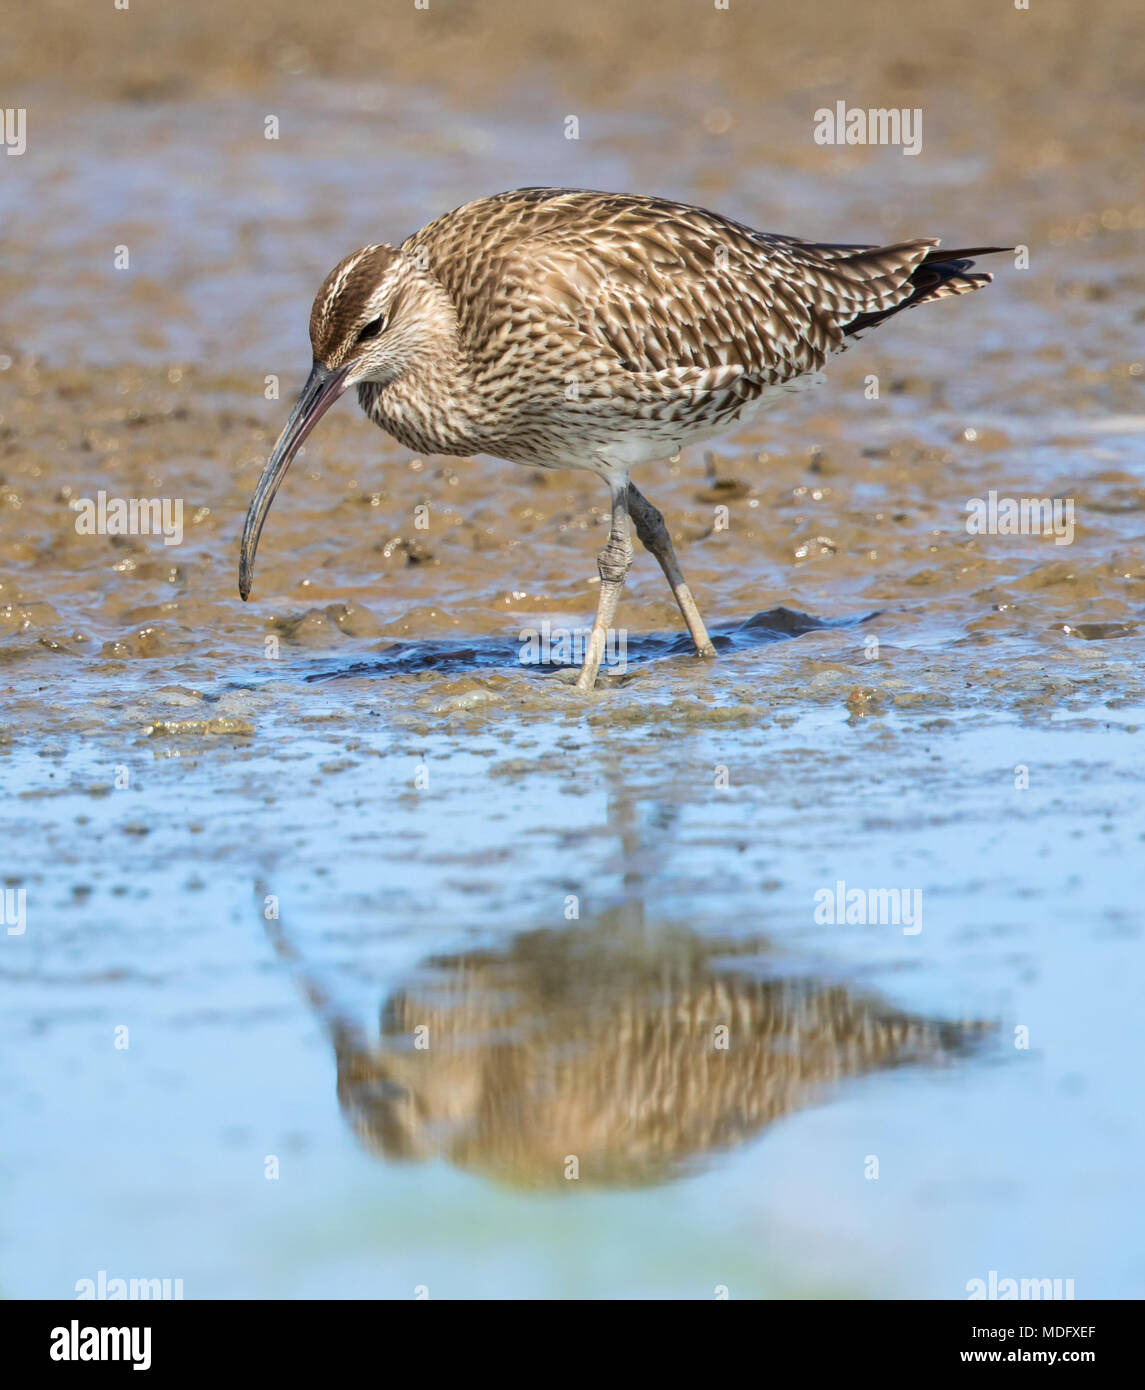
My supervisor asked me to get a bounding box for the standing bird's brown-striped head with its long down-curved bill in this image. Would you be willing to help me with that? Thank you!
[239,245,441,599]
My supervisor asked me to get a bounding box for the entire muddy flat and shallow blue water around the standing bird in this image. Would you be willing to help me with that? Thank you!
[0,7,1145,1297]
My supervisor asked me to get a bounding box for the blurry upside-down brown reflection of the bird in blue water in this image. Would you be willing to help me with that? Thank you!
[264,799,982,1187]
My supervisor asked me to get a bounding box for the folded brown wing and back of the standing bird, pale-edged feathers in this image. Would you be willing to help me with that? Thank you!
[413,189,937,393]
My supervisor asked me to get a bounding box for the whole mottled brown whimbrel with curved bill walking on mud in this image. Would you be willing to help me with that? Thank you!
[239,188,1006,689]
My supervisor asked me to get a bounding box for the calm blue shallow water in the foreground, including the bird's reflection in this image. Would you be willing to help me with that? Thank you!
[3,678,1145,1297]
